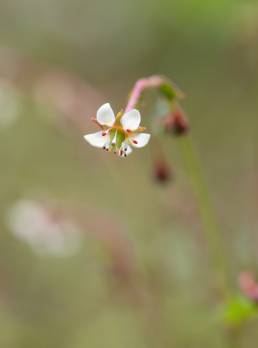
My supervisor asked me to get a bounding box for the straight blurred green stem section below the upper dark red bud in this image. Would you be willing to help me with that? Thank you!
[179,135,230,297]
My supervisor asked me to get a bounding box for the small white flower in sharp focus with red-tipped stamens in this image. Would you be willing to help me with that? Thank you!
[84,103,150,157]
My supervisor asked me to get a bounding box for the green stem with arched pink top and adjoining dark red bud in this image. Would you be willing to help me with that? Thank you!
[125,75,229,295]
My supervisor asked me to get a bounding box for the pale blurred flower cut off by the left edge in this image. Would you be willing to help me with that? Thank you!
[0,80,21,128]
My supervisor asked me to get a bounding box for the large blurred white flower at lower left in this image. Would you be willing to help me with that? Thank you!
[7,199,81,256]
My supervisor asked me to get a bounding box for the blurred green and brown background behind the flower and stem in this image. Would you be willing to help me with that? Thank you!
[0,0,258,348]
